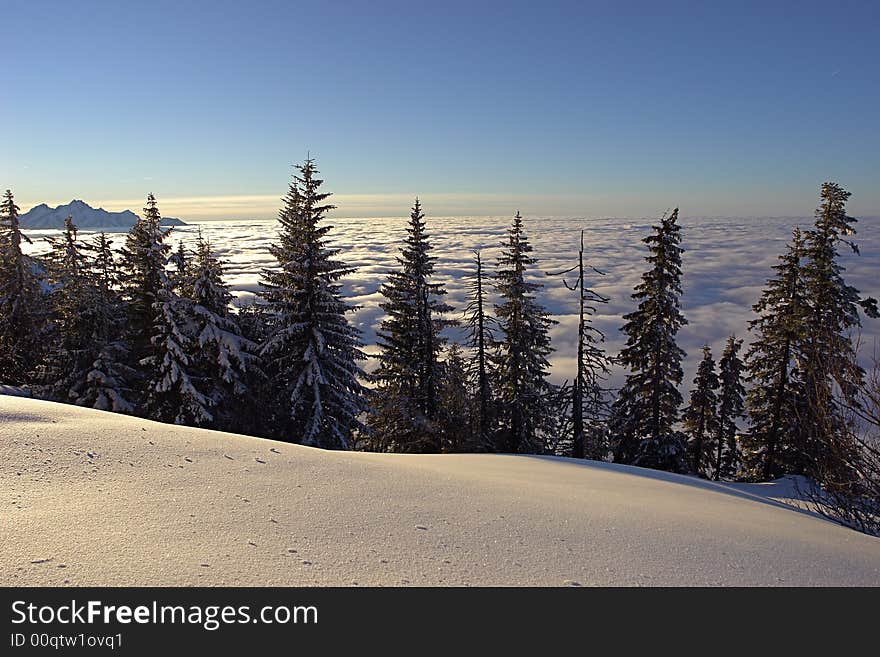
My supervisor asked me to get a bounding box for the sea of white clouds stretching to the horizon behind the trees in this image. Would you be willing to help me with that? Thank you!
[18,215,880,390]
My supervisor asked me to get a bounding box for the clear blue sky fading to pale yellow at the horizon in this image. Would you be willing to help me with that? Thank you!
[0,0,880,218]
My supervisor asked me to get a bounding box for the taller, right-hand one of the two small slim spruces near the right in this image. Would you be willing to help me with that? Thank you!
[712,335,745,481]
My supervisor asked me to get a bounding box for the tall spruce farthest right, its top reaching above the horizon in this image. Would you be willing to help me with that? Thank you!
[800,182,864,485]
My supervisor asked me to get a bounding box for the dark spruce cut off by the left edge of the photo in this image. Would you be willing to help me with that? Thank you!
[0,189,46,385]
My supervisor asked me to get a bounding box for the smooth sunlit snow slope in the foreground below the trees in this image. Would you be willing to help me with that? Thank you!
[0,396,880,586]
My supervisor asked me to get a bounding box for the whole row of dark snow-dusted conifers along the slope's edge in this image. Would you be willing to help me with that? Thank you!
[0,159,877,528]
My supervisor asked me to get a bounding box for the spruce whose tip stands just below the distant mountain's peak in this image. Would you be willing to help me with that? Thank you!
[42,217,99,401]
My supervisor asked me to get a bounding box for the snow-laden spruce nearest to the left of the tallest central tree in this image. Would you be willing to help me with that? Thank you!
[181,231,258,433]
